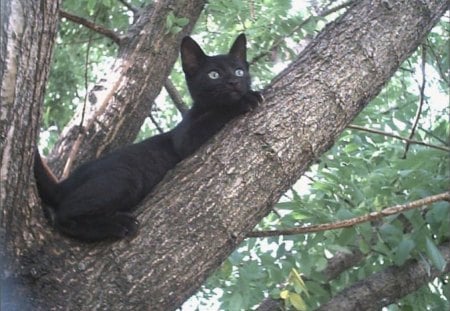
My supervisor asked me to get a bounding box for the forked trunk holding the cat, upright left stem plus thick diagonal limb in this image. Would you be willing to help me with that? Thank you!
[1,0,449,310]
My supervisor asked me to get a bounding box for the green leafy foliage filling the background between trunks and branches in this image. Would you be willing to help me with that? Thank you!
[40,0,450,310]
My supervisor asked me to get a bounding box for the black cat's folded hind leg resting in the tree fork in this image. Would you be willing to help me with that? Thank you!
[54,175,139,242]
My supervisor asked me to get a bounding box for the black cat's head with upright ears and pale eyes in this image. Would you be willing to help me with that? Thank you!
[181,34,250,108]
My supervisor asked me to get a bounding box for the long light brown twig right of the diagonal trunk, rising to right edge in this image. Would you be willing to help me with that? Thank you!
[247,191,450,237]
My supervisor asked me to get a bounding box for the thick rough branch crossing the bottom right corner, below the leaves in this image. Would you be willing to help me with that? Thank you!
[318,242,450,311]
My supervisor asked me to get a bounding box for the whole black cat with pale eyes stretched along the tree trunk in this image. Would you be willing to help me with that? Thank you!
[34,34,262,242]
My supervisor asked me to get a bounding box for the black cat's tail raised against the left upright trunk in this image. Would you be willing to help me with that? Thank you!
[34,148,59,208]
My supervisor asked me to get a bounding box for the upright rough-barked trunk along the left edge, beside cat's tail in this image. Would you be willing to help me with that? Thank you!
[0,0,59,310]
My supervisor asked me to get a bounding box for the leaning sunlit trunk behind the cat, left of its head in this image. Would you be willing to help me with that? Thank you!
[50,0,206,175]
